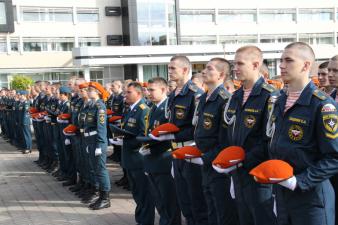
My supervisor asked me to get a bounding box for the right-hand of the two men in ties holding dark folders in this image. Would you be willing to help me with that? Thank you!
[140,77,181,225]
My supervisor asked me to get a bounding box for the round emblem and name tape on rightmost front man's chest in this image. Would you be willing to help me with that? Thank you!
[286,116,311,143]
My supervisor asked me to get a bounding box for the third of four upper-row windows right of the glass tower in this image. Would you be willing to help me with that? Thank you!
[259,9,296,22]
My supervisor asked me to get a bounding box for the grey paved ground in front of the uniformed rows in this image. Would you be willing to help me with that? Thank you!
[0,138,139,225]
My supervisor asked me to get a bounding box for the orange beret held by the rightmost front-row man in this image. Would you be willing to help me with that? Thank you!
[250,159,293,184]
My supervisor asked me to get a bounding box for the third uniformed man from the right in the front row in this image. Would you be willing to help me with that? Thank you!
[188,58,238,225]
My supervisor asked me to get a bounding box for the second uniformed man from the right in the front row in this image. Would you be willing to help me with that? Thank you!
[222,46,277,225]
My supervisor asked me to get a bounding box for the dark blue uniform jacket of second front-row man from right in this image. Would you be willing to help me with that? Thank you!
[222,77,276,171]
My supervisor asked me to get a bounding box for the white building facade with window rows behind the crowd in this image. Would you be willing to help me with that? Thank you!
[0,0,338,86]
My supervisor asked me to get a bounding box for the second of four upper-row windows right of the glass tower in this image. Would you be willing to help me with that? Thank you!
[217,10,257,23]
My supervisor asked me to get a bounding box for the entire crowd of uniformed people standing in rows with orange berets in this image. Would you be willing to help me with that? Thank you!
[0,42,338,225]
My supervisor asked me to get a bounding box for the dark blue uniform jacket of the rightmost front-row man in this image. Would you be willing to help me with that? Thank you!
[268,81,338,191]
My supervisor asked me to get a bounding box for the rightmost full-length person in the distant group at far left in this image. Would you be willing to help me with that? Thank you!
[19,90,32,154]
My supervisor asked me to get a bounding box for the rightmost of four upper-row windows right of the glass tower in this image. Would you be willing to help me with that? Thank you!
[298,9,333,22]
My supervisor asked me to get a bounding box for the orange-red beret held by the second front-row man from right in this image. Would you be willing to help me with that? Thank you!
[212,146,245,169]
